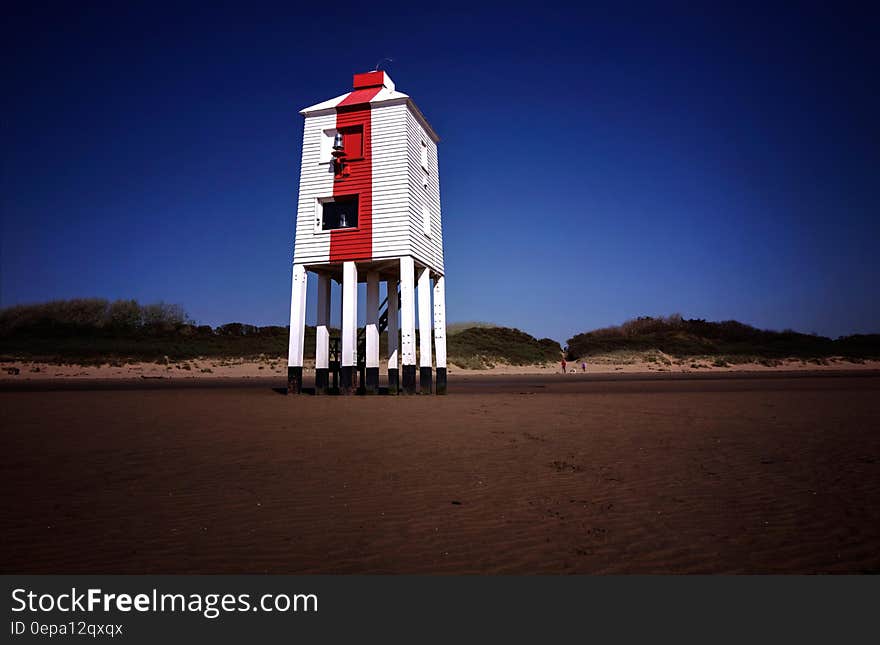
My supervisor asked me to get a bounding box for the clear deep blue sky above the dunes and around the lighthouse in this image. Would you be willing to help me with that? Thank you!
[0,2,880,342]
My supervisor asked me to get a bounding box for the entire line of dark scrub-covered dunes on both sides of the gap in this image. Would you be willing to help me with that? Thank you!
[0,299,880,369]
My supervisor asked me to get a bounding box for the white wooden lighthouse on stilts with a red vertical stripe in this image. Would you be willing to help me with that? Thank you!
[287,71,446,394]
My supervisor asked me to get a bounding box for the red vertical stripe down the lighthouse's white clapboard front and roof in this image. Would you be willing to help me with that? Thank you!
[330,87,382,262]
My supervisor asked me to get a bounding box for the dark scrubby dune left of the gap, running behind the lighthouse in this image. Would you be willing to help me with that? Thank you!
[0,299,562,369]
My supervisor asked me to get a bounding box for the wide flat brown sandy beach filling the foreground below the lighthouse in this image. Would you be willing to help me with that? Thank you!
[0,372,880,573]
